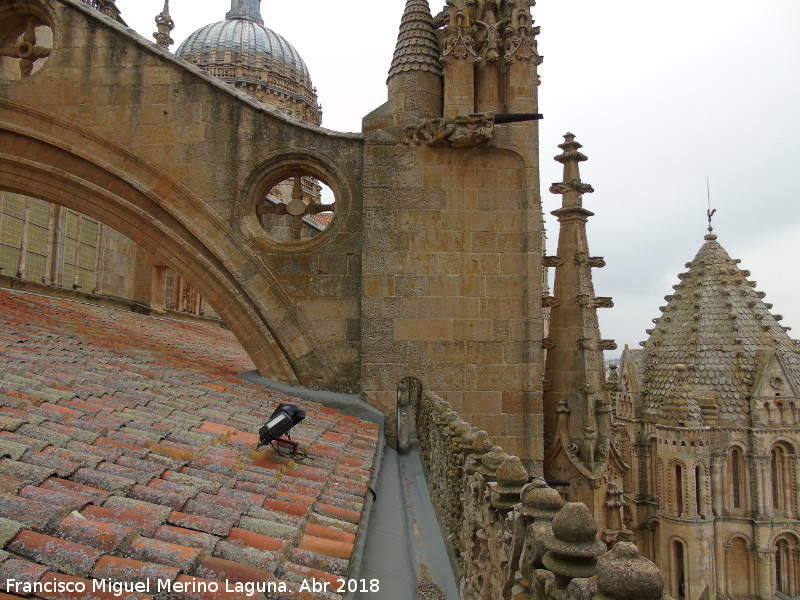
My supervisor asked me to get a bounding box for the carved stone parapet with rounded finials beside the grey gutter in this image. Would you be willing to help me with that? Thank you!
[416,391,666,600]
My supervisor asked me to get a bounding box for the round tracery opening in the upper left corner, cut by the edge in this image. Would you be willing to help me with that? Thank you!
[0,4,53,81]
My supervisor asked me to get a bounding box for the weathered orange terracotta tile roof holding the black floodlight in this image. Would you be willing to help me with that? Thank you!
[0,290,379,600]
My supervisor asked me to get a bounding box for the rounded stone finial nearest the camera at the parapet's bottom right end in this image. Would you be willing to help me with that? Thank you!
[596,542,664,600]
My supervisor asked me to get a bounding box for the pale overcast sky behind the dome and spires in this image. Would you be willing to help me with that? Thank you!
[117,0,800,357]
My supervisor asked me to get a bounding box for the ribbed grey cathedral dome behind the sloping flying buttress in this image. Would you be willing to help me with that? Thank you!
[176,0,322,125]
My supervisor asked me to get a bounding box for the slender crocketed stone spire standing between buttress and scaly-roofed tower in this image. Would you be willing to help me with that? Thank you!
[544,133,616,481]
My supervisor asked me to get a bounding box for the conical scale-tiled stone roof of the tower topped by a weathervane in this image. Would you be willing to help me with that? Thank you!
[644,234,800,425]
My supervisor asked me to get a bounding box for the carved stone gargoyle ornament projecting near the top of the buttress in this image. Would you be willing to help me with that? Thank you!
[403,113,494,148]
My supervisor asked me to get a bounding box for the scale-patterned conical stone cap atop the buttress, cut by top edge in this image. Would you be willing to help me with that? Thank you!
[389,0,442,79]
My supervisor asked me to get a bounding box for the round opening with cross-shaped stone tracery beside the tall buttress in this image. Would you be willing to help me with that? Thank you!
[256,171,336,243]
